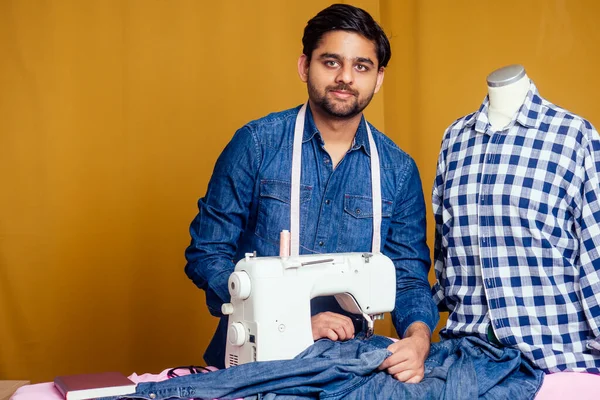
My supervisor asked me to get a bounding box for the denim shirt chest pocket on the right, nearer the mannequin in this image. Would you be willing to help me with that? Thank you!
[338,194,393,252]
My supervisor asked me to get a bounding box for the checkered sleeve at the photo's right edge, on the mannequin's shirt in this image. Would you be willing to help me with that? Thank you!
[575,121,600,337]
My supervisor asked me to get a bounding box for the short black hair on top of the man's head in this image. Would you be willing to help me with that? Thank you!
[302,4,392,67]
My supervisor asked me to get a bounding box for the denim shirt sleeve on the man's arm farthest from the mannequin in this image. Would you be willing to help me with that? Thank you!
[185,126,260,316]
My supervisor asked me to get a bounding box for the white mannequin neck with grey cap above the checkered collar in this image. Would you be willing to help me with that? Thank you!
[487,65,530,130]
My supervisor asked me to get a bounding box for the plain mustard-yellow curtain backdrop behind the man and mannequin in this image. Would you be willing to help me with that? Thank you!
[0,0,600,382]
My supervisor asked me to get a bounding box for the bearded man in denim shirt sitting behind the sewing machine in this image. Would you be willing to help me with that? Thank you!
[185,4,438,382]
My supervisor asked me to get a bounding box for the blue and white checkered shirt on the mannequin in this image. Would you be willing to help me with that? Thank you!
[433,83,600,372]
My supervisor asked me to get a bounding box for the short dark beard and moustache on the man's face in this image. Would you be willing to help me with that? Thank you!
[307,75,375,119]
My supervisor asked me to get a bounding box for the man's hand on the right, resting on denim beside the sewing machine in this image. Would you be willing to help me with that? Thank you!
[378,322,431,383]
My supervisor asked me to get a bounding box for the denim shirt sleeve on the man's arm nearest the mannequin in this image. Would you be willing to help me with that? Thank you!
[384,155,439,337]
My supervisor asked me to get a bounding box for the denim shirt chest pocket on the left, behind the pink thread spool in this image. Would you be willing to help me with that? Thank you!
[254,179,313,247]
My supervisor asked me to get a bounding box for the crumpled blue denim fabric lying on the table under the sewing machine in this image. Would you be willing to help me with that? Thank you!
[97,336,543,400]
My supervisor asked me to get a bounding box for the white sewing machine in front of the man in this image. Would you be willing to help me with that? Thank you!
[222,253,396,367]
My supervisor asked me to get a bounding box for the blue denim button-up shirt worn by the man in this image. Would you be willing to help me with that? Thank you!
[185,107,439,367]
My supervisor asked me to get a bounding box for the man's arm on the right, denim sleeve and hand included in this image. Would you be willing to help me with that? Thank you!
[380,159,439,383]
